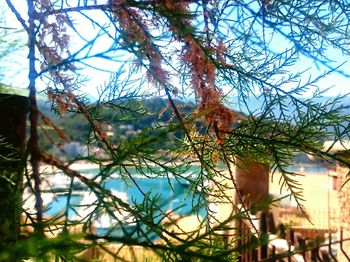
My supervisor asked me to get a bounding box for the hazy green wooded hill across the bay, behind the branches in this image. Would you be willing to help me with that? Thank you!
[39,97,194,149]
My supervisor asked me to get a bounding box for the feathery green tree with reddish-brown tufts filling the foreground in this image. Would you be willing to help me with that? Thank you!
[0,0,350,261]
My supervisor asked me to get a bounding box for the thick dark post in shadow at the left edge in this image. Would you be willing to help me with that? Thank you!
[0,94,28,243]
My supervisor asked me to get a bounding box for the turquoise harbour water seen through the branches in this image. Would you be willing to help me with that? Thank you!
[45,172,206,240]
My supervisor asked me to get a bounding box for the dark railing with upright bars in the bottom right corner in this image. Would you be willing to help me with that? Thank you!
[239,214,350,262]
